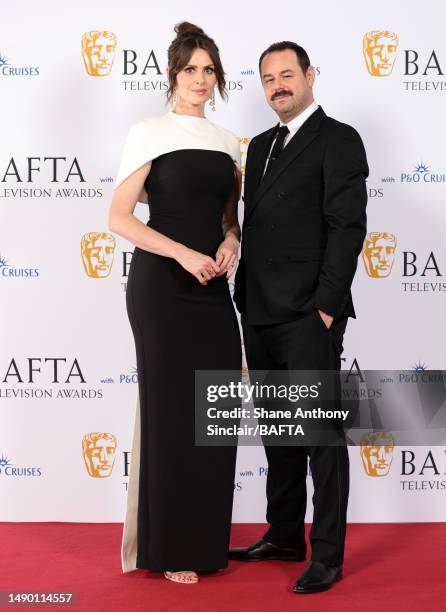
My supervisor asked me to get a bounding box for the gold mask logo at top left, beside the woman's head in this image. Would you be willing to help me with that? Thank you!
[82,30,117,76]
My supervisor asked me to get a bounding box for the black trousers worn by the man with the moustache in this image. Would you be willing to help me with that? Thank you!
[242,310,349,566]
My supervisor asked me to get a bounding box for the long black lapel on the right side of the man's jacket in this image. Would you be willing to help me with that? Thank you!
[246,107,325,221]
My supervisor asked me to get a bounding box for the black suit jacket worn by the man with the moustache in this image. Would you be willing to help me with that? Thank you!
[234,107,368,325]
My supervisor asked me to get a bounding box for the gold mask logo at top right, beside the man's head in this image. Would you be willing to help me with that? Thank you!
[362,30,398,76]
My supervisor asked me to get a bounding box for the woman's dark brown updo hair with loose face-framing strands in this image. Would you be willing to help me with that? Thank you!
[166,21,227,102]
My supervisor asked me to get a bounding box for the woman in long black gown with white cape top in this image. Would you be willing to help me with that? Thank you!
[109,23,241,583]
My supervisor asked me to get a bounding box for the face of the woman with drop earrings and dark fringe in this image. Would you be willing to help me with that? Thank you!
[176,49,217,106]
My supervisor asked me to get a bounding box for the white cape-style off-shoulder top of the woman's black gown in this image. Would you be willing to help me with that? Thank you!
[114,111,241,204]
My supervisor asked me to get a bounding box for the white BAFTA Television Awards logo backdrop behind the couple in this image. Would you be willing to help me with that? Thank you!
[0,0,446,522]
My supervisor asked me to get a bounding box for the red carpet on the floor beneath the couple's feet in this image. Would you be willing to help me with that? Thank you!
[0,523,446,612]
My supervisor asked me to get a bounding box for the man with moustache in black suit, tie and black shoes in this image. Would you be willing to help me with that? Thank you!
[230,42,368,593]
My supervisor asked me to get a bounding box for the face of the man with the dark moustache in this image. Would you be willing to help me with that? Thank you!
[260,49,315,122]
